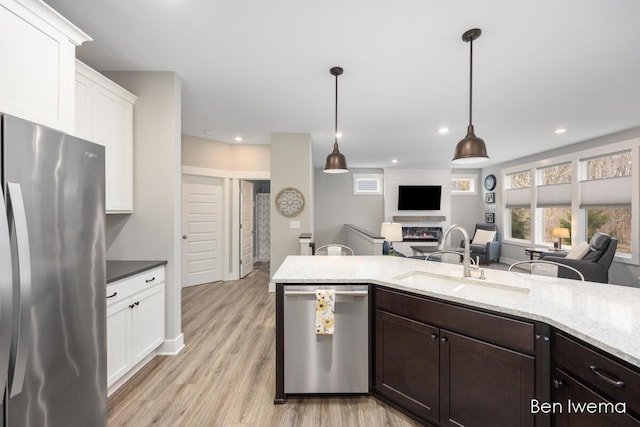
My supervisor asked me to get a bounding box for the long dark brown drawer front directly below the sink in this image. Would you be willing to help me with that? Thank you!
[376,287,535,354]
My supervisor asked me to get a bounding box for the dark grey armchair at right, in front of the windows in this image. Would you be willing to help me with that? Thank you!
[540,232,618,283]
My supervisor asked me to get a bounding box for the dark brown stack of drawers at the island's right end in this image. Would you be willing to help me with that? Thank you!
[552,333,640,427]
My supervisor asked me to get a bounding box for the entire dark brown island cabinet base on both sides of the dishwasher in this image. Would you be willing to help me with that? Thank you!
[275,285,640,427]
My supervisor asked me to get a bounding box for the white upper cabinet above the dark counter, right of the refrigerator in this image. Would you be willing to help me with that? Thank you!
[73,61,136,213]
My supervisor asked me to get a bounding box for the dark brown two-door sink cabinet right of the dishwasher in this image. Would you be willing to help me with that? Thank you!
[375,288,535,426]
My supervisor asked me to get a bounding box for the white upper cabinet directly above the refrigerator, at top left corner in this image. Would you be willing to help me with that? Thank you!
[0,0,91,133]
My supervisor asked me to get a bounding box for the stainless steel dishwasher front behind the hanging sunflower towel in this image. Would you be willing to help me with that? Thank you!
[284,285,369,394]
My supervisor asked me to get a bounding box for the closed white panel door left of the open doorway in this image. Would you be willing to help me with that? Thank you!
[182,176,222,287]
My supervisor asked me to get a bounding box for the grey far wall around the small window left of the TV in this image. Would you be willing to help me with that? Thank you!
[314,168,384,247]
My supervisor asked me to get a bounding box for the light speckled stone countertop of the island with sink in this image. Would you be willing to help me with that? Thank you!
[272,256,640,367]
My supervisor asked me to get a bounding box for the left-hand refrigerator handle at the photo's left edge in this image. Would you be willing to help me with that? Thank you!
[0,192,13,396]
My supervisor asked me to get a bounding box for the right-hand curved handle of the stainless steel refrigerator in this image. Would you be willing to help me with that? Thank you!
[7,182,31,397]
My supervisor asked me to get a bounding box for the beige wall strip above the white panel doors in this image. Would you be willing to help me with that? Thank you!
[182,135,271,171]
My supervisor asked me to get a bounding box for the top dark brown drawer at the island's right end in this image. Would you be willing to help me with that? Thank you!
[554,333,640,414]
